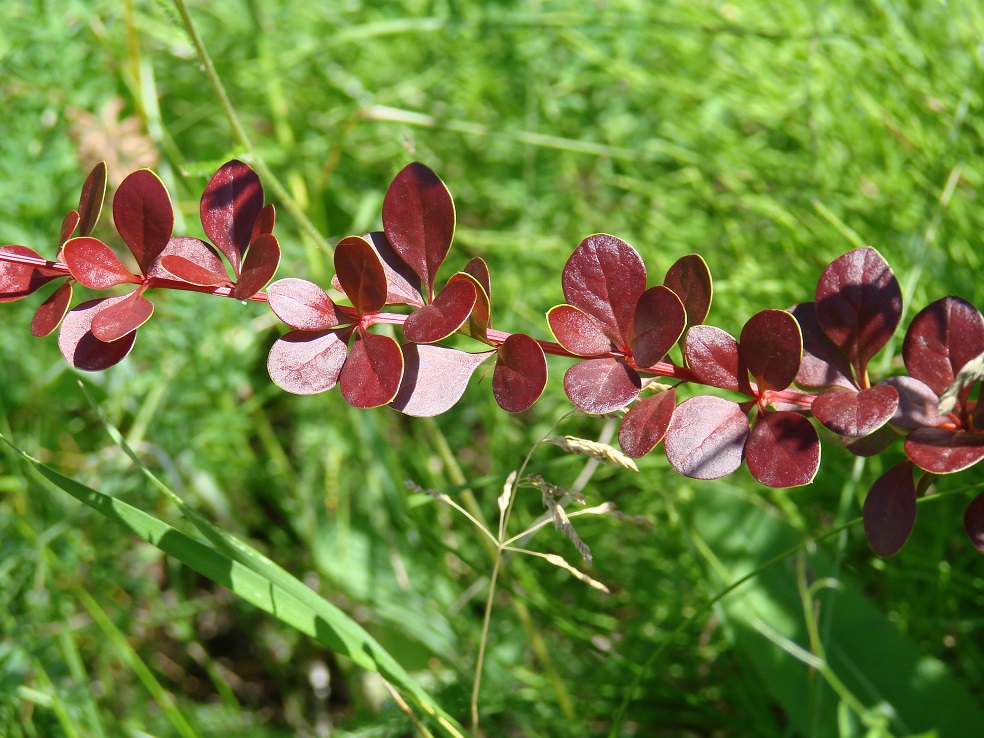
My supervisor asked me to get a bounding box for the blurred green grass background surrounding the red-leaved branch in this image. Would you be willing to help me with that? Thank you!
[0,0,984,738]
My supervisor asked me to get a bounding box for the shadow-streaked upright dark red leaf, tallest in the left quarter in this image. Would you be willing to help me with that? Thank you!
[199,159,264,274]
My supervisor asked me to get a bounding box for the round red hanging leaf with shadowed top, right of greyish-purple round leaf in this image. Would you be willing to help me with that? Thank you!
[745,411,820,489]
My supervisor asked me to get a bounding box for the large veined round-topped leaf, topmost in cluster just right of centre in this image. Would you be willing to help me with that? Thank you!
[562,233,646,353]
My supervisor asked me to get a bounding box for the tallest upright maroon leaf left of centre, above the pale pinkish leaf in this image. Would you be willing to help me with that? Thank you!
[383,162,455,298]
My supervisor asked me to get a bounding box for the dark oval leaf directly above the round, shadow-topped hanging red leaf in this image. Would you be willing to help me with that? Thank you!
[738,310,803,392]
